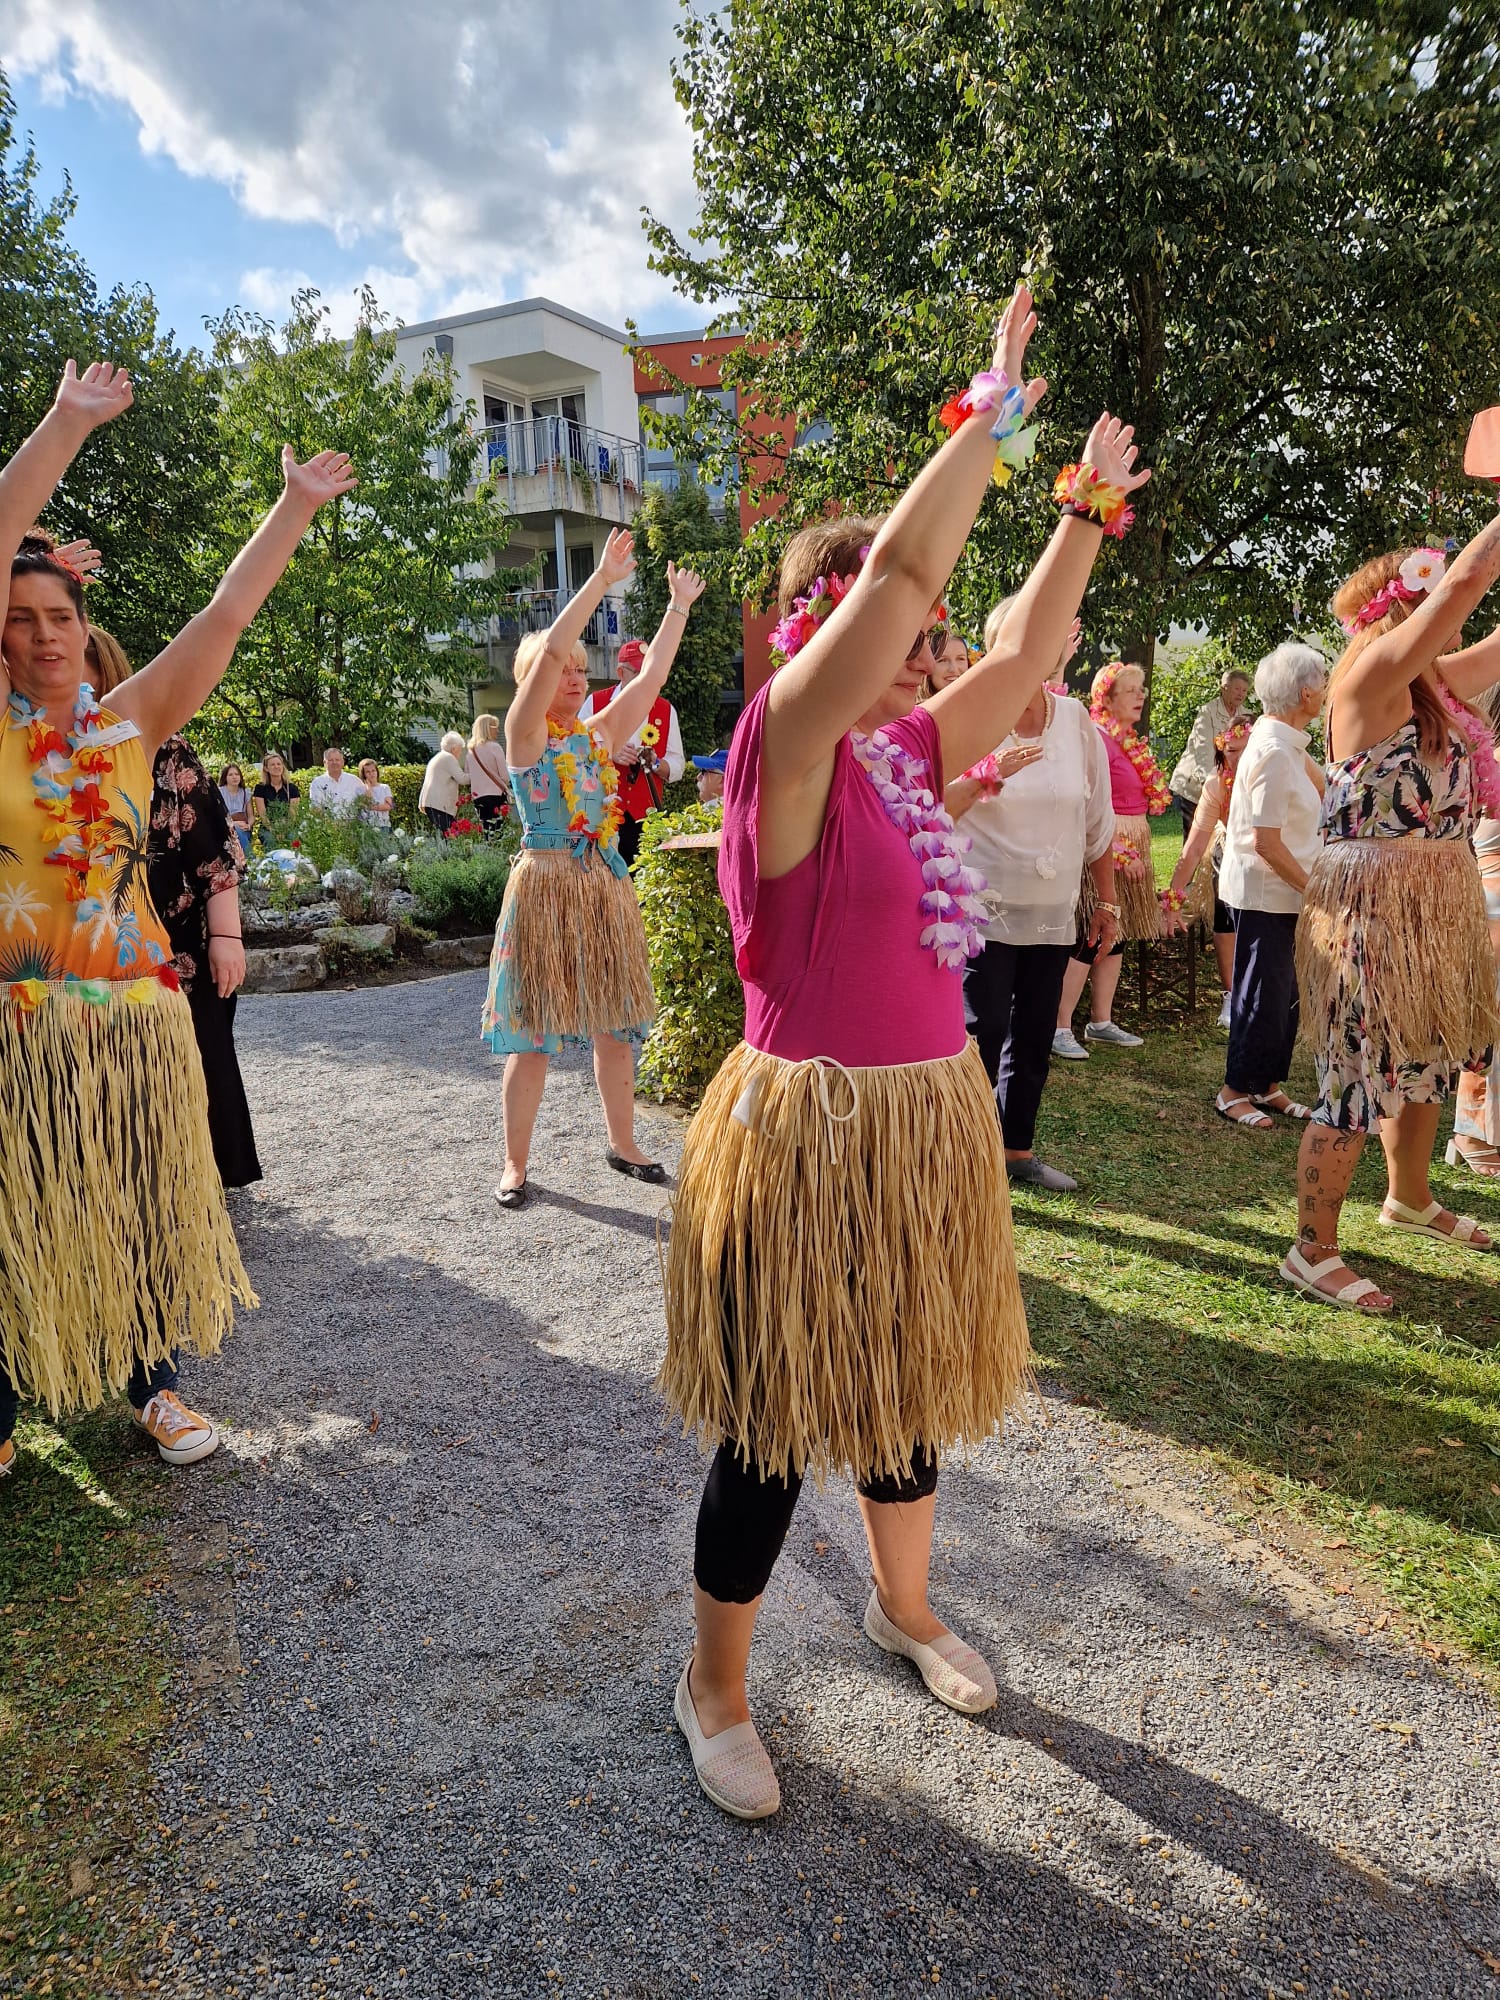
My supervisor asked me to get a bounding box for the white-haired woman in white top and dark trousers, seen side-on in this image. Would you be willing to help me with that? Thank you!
[1214,642,1328,1132]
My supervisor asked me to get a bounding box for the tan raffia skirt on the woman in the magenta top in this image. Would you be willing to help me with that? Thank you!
[660,1042,1030,1478]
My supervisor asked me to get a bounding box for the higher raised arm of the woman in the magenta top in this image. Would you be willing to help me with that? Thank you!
[762,284,1062,788]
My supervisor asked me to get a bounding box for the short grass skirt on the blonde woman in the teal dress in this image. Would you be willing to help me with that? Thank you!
[480,848,656,1056]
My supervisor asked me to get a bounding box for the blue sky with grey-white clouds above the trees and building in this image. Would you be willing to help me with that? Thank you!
[0,0,698,340]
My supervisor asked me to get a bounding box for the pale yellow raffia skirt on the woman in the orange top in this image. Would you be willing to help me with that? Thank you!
[0,986,256,1416]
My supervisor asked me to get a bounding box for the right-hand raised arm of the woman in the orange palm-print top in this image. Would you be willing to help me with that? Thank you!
[110,444,356,746]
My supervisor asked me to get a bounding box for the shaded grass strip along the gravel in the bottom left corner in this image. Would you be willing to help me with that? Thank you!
[0,1402,170,2000]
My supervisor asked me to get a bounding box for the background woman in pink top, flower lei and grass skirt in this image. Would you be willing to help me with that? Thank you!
[1052,660,1172,1062]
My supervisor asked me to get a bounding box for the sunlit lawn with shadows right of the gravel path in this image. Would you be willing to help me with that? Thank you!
[1014,834,1500,1666]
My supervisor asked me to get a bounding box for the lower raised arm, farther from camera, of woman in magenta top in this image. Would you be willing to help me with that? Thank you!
[926,412,1150,770]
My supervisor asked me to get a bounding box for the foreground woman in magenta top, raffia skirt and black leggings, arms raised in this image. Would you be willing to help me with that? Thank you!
[662,288,1144,1818]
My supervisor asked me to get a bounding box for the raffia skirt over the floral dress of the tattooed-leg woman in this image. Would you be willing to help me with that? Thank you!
[1296,836,1500,1068]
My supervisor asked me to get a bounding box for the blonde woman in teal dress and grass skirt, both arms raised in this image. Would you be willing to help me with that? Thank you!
[480,530,704,1208]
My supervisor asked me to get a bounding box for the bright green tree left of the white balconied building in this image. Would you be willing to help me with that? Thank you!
[202,292,522,760]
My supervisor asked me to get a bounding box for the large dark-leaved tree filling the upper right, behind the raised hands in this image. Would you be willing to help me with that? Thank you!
[648,0,1500,688]
